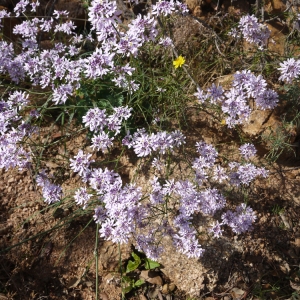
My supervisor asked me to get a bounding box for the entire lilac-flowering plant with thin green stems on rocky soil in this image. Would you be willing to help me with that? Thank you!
[0,0,300,298]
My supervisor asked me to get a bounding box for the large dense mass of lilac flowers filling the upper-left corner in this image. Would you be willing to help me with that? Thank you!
[0,0,179,104]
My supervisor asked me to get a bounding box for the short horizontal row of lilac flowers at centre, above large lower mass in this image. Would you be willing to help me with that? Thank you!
[122,129,185,157]
